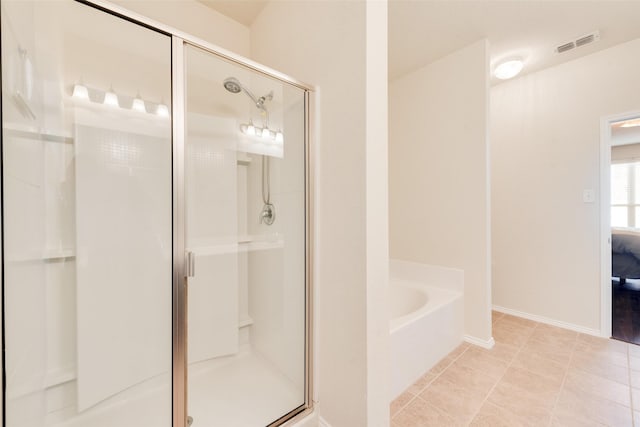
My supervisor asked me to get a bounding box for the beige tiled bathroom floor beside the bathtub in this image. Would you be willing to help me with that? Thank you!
[391,312,640,427]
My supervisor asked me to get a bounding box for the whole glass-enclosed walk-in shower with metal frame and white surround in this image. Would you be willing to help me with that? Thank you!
[0,0,312,427]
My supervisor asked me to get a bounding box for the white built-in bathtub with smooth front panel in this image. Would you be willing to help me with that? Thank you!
[389,260,464,399]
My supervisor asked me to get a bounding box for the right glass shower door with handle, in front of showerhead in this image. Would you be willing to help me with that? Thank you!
[185,44,307,427]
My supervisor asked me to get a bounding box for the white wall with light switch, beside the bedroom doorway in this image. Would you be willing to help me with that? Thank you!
[491,40,640,330]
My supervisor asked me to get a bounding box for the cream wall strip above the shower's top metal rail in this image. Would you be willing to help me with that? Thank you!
[111,0,250,57]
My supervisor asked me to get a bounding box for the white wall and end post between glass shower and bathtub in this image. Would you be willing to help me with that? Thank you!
[251,1,389,427]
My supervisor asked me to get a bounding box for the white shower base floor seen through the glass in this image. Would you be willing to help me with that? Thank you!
[45,350,304,427]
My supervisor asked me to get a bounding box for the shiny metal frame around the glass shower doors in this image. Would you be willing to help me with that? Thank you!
[0,0,315,427]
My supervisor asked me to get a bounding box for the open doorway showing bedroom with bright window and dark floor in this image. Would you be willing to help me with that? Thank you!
[609,116,640,345]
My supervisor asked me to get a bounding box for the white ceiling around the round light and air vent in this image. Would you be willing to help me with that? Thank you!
[389,0,640,83]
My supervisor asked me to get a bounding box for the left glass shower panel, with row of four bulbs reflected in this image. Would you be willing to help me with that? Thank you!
[1,0,172,427]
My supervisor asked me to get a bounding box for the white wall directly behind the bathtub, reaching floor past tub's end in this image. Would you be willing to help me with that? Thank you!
[389,41,491,344]
